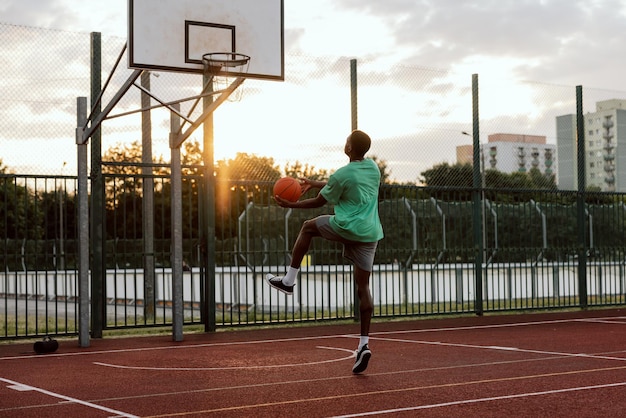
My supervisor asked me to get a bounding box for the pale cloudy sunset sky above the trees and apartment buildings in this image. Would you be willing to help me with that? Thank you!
[0,0,626,181]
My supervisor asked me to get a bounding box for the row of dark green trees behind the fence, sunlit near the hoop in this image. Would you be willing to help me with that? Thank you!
[0,142,626,270]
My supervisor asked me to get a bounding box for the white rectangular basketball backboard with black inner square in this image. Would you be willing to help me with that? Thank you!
[128,0,285,80]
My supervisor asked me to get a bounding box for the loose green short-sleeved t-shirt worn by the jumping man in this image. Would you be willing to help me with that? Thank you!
[320,159,384,242]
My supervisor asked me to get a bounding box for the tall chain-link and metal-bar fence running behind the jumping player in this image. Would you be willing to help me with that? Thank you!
[0,24,626,338]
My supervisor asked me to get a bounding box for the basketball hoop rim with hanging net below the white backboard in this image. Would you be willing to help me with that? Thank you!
[202,52,250,102]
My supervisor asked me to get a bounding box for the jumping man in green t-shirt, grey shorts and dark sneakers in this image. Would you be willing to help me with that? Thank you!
[266,130,383,373]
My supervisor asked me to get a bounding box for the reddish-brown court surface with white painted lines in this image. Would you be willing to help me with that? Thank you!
[0,309,626,418]
